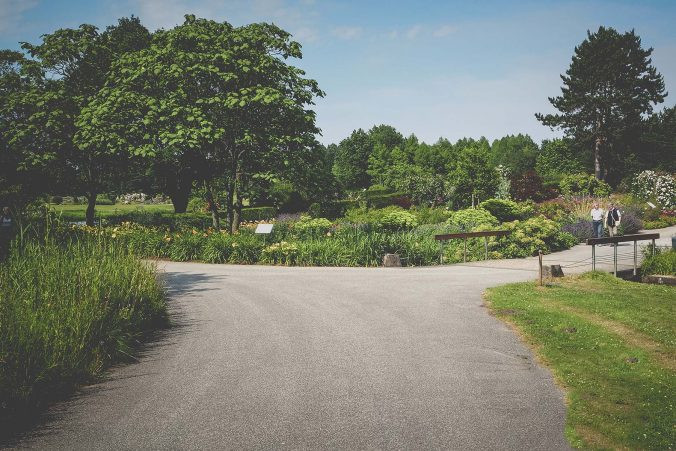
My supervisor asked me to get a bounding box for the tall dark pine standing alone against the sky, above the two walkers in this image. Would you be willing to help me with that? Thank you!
[536,27,666,179]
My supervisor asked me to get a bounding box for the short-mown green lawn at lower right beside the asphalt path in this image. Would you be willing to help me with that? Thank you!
[486,273,676,449]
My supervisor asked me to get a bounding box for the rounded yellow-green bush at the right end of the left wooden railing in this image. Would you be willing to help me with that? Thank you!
[491,216,578,258]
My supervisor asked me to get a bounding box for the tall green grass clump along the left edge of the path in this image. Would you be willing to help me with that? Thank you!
[0,236,166,430]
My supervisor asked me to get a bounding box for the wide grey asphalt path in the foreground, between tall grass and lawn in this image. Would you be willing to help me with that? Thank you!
[11,262,568,450]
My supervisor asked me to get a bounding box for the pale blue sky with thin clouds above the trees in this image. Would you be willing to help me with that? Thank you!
[0,0,676,144]
